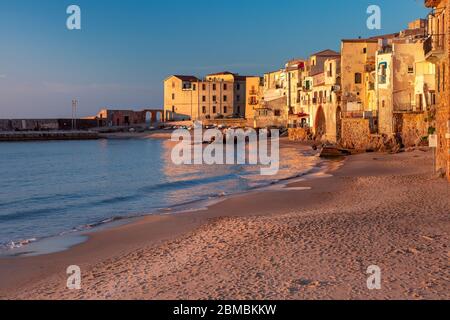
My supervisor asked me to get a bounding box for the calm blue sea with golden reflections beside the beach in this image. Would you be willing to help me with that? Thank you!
[0,139,320,253]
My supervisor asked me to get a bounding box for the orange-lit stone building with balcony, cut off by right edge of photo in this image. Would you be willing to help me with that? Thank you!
[424,0,450,180]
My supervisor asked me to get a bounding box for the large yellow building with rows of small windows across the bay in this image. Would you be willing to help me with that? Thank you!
[164,72,253,121]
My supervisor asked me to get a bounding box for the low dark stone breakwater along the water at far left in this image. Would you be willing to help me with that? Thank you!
[0,131,99,142]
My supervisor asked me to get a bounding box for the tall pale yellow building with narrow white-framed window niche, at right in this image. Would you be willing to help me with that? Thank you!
[375,33,435,139]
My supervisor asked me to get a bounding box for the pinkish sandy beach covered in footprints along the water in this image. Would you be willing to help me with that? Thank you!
[0,150,450,299]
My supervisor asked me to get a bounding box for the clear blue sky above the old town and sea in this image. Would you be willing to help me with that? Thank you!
[0,0,428,118]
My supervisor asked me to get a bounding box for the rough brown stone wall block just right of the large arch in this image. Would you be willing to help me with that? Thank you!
[341,118,370,150]
